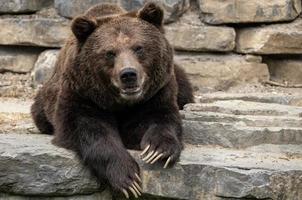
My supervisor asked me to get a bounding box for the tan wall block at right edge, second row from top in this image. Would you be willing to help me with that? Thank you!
[236,18,302,54]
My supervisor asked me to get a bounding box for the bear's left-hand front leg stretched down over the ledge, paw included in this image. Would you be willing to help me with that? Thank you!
[53,96,142,198]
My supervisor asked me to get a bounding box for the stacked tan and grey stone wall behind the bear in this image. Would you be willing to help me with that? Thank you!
[0,0,302,94]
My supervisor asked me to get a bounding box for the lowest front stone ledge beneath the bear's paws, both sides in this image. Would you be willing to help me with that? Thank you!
[0,134,302,200]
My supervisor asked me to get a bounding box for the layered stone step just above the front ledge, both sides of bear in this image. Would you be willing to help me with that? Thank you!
[0,99,302,148]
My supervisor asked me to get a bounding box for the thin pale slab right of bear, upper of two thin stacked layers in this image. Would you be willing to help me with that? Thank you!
[184,100,302,117]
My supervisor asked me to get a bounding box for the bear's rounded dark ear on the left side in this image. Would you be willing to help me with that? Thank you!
[71,16,97,42]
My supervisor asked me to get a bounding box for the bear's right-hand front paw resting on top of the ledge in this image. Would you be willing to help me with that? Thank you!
[140,127,182,168]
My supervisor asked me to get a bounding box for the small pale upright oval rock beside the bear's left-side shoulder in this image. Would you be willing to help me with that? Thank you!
[32,50,59,85]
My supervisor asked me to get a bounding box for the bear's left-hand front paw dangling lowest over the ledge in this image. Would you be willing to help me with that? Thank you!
[106,155,142,199]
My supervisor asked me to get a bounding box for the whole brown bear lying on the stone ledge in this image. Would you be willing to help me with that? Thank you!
[31,3,193,197]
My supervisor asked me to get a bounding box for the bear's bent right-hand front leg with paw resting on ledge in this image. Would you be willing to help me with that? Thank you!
[141,108,182,168]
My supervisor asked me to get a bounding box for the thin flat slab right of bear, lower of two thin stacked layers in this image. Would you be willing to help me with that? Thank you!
[181,111,302,128]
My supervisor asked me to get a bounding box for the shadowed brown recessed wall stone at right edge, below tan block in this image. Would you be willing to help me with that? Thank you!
[265,57,302,85]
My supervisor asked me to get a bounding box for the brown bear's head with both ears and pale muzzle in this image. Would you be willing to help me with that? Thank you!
[68,3,174,103]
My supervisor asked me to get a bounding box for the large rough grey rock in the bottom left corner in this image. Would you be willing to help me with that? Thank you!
[0,134,99,196]
